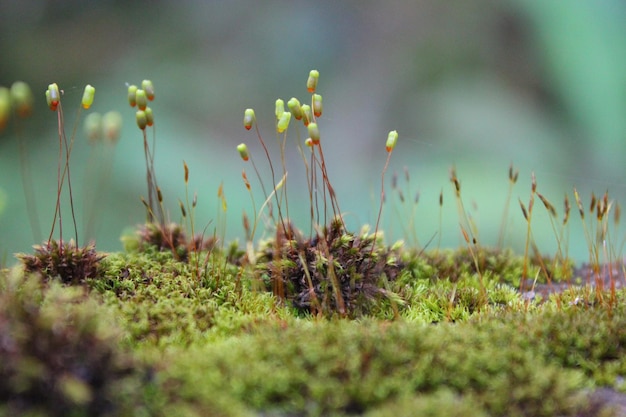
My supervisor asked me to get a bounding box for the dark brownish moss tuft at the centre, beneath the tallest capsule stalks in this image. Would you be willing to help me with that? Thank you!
[257,219,402,318]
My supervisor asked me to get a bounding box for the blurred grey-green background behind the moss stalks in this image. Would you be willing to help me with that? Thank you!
[0,0,626,263]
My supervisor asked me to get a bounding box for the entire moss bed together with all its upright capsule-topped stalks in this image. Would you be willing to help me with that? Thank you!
[0,70,626,416]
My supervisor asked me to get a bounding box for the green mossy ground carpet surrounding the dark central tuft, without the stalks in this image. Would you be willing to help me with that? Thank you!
[0,237,626,416]
